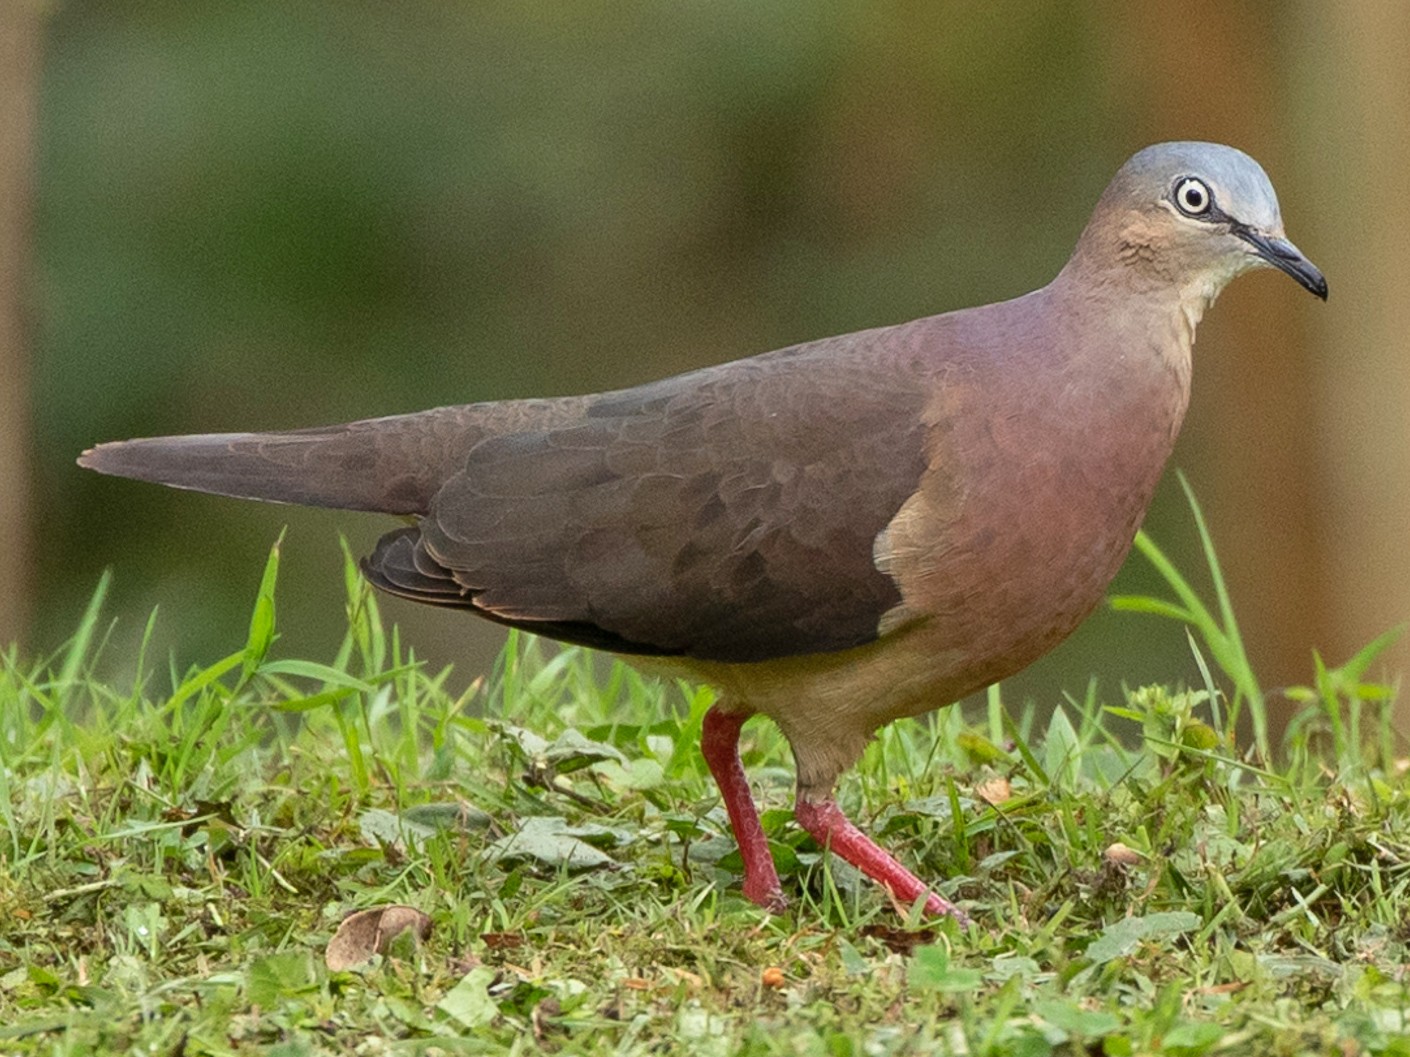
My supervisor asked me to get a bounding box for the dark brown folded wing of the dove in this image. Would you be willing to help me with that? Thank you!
[367,333,925,661]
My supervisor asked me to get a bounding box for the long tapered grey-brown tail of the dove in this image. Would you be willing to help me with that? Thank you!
[79,407,478,514]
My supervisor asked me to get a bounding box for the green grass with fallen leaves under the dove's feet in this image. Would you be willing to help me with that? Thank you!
[0,507,1410,1057]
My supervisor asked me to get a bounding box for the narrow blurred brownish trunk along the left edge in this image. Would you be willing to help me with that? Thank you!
[0,0,47,645]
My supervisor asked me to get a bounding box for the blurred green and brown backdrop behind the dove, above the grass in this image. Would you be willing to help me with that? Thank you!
[11,0,1410,721]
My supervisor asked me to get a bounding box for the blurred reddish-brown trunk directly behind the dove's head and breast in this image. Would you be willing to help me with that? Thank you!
[1112,0,1341,699]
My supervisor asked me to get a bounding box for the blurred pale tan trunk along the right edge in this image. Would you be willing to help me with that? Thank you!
[1292,0,1410,696]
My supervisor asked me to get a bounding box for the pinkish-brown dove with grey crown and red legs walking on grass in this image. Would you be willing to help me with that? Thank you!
[79,142,1327,920]
